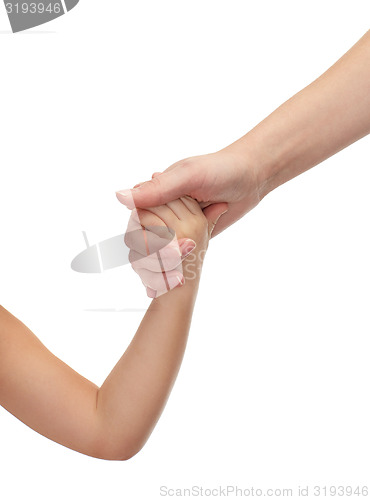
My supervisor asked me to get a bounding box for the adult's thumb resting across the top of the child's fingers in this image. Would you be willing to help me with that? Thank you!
[116,167,192,209]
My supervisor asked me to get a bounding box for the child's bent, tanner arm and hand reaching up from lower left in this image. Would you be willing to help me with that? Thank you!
[0,198,227,460]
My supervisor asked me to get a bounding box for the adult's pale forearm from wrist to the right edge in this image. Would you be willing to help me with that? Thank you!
[226,31,370,198]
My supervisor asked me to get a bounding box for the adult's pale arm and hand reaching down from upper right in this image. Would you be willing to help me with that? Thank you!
[117,31,370,296]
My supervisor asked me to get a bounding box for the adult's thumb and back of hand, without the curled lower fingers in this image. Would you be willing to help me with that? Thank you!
[116,146,260,236]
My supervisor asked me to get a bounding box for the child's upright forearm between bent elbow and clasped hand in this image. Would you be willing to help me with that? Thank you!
[97,279,198,459]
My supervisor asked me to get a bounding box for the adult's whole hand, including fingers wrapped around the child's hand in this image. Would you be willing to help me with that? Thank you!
[117,150,251,298]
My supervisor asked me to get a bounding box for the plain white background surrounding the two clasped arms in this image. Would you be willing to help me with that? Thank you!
[0,0,370,500]
